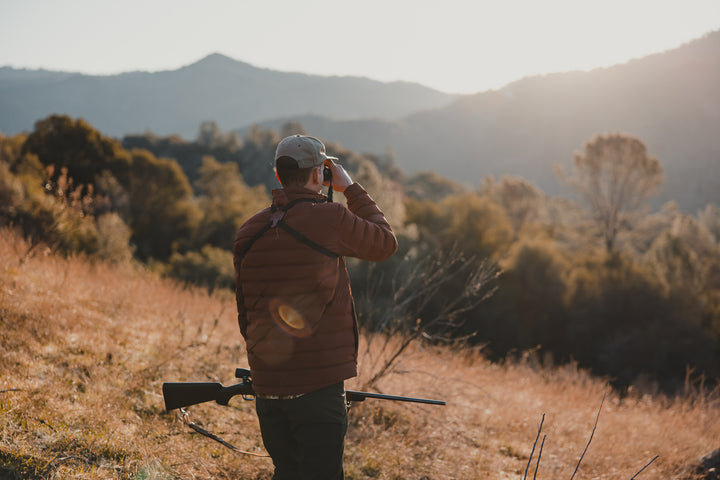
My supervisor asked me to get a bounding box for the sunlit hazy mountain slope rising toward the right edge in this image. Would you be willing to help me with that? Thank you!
[248,31,720,212]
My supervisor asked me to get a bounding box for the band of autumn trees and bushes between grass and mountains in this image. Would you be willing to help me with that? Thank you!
[0,115,720,391]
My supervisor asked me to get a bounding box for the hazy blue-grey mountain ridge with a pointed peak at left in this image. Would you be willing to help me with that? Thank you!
[0,54,457,139]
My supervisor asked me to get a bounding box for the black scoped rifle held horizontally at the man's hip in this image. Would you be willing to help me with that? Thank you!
[163,368,445,411]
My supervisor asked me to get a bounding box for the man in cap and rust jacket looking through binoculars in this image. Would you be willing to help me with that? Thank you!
[233,135,397,480]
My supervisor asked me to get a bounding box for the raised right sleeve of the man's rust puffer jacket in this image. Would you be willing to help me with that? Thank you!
[336,183,398,262]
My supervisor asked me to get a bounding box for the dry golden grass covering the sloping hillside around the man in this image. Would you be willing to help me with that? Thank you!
[0,226,720,480]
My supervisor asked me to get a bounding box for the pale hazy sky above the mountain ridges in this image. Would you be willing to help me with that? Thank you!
[0,0,720,93]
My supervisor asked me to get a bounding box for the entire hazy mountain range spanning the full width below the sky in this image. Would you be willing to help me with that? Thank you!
[0,31,720,212]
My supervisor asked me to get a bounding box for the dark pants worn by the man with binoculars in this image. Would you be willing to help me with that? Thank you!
[255,382,347,480]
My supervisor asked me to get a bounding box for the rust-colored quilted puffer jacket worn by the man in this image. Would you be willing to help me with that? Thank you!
[233,183,397,395]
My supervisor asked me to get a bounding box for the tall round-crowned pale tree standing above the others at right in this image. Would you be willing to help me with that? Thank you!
[564,133,663,253]
